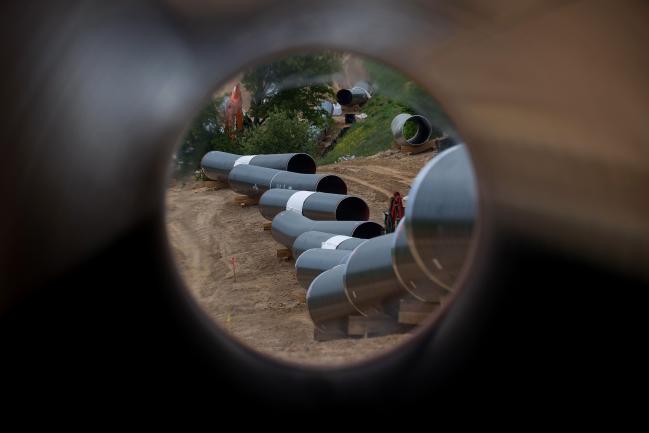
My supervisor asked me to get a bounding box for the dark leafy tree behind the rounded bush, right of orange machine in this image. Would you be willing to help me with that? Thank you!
[242,52,341,127]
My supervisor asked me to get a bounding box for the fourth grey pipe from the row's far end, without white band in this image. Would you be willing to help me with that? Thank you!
[271,211,383,248]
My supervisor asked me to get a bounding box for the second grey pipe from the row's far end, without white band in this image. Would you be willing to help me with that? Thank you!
[228,164,347,197]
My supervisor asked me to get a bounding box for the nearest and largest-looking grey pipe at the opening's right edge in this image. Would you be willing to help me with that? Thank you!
[405,145,478,290]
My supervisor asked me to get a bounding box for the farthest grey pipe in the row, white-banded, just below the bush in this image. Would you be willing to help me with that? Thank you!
[201,150,316,180]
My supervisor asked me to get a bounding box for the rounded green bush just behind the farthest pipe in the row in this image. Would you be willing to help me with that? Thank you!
[243,108,316,155]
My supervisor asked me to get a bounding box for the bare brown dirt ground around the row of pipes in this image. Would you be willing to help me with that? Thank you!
[167,151,433,365]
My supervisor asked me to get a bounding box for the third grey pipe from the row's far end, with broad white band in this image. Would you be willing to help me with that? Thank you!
[259,188,370,221]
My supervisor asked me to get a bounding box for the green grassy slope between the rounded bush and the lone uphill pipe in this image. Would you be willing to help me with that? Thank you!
[318,95,408,165]
